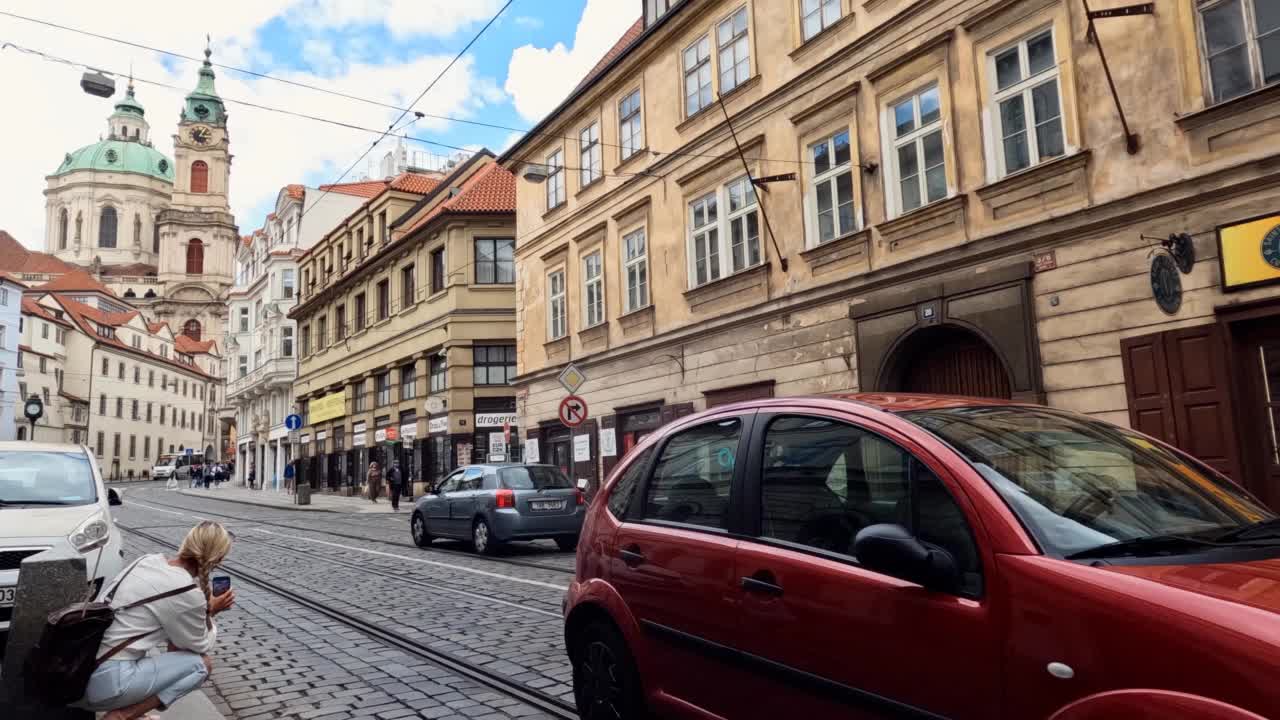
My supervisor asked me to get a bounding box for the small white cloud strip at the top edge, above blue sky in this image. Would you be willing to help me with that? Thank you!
[289,0,502,37]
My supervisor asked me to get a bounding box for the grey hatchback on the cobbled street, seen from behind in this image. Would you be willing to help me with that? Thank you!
[410,464,586,555]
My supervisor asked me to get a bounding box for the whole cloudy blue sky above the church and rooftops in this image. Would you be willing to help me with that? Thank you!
[0,0,641,250]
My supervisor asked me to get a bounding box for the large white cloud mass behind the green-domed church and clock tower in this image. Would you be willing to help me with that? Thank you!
[0,0,504,249]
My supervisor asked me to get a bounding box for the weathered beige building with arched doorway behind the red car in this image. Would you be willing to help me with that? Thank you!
[500,0,1280,505]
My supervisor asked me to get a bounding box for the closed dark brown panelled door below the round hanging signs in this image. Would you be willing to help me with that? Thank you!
[1120,324,1242,482]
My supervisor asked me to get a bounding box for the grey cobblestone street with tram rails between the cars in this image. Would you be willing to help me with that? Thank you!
[115,486,573,720]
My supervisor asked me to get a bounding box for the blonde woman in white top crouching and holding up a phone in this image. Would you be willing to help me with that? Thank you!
[77,521,236,720]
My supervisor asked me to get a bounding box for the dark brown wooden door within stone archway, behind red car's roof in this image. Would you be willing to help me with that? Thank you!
[884,325,1012,400]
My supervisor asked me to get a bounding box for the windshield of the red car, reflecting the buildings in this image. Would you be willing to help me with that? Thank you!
[902,406,1274,556]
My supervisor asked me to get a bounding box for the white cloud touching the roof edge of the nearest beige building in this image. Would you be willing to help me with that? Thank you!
[504,0,640,122]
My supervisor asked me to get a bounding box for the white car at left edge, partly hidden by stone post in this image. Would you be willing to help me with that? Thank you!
[0,442,124,633]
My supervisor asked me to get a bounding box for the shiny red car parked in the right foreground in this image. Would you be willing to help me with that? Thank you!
[564,395,1280,720]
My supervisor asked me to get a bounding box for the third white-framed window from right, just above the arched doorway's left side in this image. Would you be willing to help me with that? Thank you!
[888,85,947,215]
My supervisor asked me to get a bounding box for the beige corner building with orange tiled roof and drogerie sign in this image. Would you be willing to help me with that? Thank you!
[289,151,518,493]
